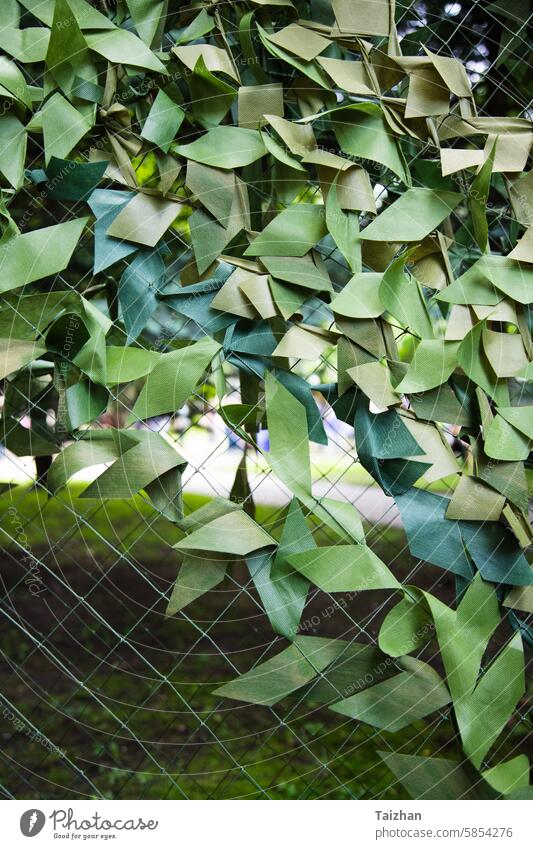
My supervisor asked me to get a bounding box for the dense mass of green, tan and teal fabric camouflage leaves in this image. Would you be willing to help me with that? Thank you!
[0,0,533,797]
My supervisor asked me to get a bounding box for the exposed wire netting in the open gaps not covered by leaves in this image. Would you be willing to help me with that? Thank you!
[0,0,531,799]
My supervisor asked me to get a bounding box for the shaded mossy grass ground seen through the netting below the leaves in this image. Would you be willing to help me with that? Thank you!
[0,485,522,799]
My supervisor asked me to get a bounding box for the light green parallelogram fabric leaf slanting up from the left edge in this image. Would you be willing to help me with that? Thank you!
[0,218,87,292]
